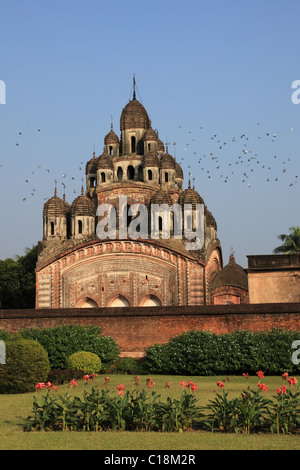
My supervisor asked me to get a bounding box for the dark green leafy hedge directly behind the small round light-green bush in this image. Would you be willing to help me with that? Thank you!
[21,325,119,370]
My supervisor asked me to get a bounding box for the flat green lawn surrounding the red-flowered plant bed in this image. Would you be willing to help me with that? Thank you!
[0,374,300,451]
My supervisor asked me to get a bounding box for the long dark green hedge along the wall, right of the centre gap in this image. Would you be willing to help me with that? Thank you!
[143,329,300,375]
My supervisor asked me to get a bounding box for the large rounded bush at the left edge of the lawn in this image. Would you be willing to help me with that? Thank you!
[0,337,50,393]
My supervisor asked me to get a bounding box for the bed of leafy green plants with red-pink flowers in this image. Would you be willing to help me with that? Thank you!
[24,371,300,434]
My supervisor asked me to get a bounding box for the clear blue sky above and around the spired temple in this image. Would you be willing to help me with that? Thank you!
[0,0,300,267]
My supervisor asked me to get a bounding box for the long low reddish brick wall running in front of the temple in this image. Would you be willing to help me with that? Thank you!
[0,303,300,356]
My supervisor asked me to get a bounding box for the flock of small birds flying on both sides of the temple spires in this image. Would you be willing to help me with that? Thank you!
[0,122,298,201]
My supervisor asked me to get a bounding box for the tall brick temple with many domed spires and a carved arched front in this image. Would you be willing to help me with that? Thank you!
[36,80,234,309]
